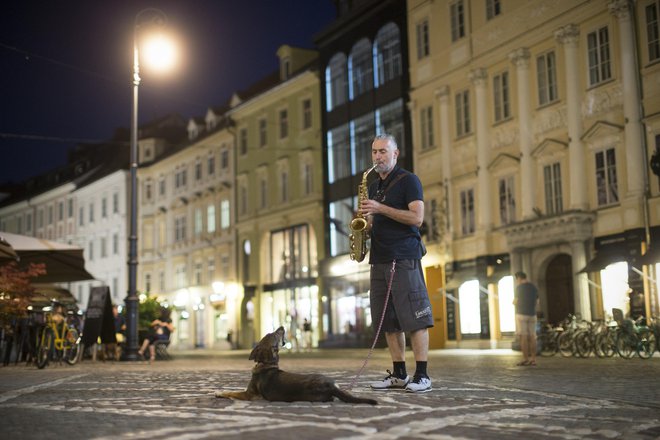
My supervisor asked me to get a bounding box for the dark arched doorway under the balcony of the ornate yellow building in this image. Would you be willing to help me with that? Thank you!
[545,254,575,324]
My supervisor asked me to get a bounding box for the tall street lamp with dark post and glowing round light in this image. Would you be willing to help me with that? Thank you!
[122,8,173,361]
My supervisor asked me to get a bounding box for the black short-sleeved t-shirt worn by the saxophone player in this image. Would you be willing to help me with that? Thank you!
[369,166,424,264]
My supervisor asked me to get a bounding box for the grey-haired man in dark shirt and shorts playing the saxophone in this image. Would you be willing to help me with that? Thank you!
[359,134,433,392]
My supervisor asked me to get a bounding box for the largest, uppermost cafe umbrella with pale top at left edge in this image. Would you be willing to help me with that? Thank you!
[0,232,94,283]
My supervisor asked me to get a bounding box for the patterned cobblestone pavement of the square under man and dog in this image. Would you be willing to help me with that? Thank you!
[0,350,660,440]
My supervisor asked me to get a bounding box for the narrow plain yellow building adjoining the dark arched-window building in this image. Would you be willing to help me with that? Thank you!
[228,45,324,348]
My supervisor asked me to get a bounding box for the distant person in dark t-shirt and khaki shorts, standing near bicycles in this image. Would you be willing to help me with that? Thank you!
[513,272,539,366]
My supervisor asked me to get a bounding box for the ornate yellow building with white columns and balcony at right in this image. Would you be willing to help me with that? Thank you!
[408,0,660,343]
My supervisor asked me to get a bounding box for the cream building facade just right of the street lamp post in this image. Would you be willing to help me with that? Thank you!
[137,113,239,348]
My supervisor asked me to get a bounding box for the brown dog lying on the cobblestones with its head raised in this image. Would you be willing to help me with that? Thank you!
[215,327,378,405]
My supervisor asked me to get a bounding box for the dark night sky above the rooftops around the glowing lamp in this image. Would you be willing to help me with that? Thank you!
[0,0,335,184]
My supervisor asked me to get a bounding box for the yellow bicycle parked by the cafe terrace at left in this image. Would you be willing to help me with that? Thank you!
[36,306,80,369]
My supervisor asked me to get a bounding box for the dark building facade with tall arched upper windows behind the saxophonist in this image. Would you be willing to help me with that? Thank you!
[315,1,413,346]
